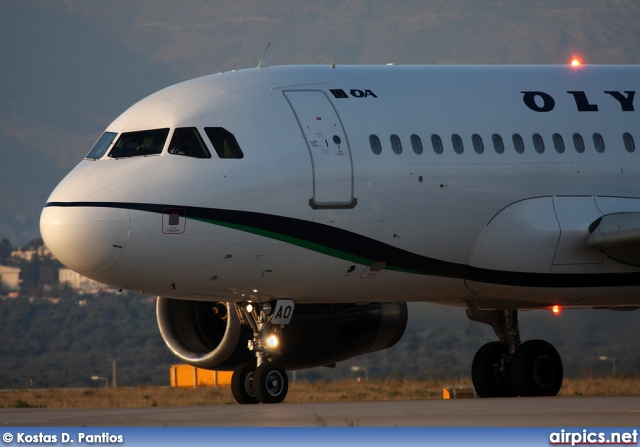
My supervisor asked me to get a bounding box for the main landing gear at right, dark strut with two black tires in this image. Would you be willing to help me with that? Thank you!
[467,306,563,397]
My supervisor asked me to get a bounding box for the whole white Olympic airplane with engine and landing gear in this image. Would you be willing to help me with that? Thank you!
[40,60,640,404]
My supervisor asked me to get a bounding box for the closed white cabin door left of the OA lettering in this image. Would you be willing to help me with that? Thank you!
[284,90,357,209]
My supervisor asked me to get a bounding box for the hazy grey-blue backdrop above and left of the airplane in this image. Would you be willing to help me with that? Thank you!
[0,0,640,246]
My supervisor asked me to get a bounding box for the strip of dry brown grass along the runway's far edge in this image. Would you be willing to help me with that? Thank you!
[0,378,640,408]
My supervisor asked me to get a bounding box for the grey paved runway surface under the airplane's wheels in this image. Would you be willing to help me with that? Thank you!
[0,396,640,427]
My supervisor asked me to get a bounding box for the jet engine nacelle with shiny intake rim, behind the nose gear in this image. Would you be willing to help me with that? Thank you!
[156,297,407,371]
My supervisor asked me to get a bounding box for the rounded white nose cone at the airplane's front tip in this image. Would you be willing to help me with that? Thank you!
[40,175,129,281]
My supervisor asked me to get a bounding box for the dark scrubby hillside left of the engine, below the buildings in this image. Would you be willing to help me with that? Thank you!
[0,294,173,388]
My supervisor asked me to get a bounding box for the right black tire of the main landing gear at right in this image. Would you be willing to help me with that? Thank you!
[511,340,564,397]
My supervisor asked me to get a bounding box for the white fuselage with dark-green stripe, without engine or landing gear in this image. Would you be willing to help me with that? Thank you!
[41,66,640,308]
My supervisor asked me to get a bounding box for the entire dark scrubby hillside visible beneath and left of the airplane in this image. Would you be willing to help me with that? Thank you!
[0,293,640,389]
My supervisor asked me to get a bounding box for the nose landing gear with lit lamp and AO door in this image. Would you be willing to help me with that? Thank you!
[231,300,294,404]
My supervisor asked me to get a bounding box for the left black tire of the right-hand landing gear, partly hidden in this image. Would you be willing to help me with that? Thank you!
[471,341,516,397]
